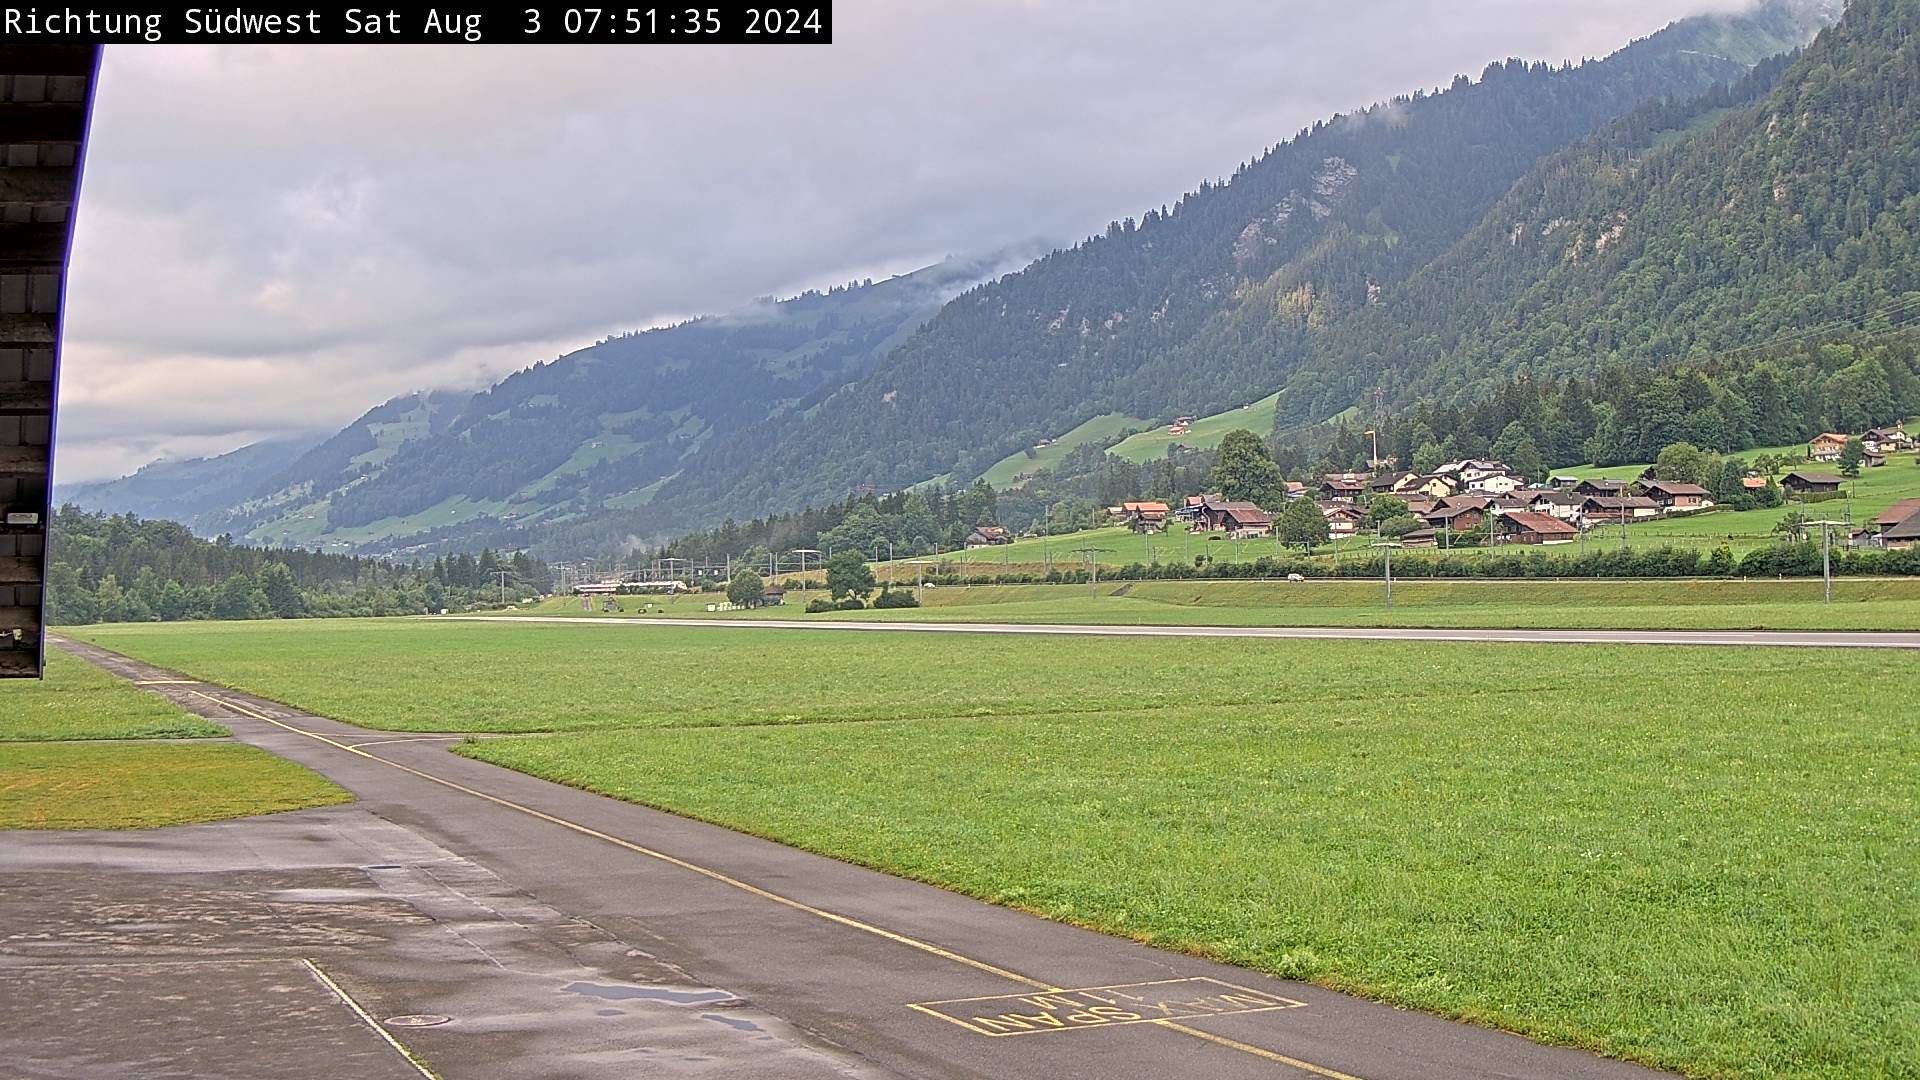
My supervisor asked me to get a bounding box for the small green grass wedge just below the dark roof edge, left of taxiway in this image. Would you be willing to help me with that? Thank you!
[0,650,227,742]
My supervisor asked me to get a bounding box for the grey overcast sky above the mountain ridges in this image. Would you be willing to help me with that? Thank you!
[58,0,1745,482]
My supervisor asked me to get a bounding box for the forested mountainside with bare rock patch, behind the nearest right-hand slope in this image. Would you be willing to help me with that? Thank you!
[655,2,1824,523]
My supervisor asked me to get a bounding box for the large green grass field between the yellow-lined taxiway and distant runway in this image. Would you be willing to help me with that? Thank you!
[52,621,1920,1078]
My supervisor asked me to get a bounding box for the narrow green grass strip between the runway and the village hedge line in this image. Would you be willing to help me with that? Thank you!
[490,578,1920,630]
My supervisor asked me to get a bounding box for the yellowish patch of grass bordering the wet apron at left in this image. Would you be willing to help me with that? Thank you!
[0,742,353,828]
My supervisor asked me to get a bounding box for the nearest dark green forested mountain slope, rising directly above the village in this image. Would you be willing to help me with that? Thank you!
[1284,0,1920,419]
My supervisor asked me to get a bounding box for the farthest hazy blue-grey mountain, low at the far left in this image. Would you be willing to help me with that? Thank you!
[56,436,319,532]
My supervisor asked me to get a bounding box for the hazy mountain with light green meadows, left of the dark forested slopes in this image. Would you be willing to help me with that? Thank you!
[168,256,1025,552]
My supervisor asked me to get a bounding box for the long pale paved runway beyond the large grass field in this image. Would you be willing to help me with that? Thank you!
[434,615,1920,650]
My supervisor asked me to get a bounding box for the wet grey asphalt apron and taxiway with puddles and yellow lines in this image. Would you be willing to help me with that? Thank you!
[22,644,1681,1080]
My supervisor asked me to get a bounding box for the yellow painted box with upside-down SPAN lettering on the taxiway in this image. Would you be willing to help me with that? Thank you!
[908,976,1306,1038]
